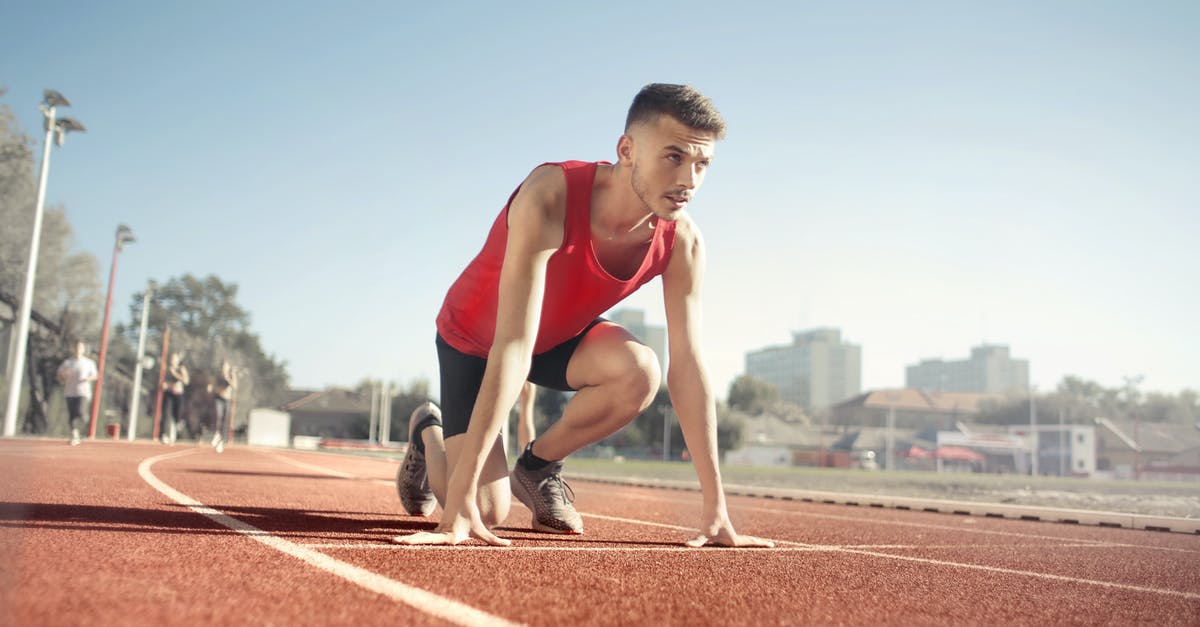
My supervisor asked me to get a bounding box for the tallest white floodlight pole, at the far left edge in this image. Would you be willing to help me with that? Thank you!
[4,89,86,437]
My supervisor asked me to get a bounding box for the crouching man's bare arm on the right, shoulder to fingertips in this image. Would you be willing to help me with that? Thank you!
[662,215,774,547]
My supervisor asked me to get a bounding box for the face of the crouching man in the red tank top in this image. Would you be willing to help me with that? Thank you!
[622,115,716,221]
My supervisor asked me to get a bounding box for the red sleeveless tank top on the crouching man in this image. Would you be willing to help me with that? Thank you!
[438,161,676,357]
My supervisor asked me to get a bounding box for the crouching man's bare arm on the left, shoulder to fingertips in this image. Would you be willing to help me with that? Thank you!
[412,166,566,544]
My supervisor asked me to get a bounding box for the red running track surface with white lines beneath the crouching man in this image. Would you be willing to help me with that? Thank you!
[0,440,1200,626]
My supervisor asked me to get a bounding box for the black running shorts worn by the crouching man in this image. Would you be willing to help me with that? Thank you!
[437,318,607,437]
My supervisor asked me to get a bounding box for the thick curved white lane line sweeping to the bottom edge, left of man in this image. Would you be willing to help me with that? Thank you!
[138,449,517,626]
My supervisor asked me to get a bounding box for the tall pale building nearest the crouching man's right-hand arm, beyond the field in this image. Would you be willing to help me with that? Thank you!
[746,329,863,412]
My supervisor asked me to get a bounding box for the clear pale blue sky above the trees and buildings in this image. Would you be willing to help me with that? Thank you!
[0,0,1200,396]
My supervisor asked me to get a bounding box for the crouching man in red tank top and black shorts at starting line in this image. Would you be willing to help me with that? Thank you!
[395,84,772,547]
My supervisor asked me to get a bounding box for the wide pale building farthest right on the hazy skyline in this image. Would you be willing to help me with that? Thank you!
[905,344,1030,394]
